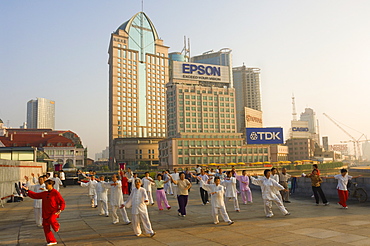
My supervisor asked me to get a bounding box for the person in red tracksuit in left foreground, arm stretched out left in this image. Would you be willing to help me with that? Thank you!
[24,179,66,245]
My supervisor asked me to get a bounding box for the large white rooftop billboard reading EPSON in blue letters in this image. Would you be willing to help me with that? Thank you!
[172,61,230,83]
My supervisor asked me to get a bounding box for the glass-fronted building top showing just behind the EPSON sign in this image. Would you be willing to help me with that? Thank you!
[191,48,233,87]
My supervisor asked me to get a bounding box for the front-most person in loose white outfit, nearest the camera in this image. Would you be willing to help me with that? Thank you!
[121,179,155,237]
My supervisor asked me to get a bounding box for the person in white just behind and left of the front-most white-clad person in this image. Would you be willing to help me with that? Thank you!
[104,174,131,225]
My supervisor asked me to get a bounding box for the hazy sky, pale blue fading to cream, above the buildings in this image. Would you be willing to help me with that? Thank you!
[0,0,370,158]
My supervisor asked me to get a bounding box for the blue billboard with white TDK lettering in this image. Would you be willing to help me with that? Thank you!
[246,127,284,144]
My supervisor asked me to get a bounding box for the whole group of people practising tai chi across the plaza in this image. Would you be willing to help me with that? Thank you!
[23,165,362,245]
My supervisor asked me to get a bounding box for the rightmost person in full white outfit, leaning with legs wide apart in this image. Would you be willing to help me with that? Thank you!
[250,169,290,218]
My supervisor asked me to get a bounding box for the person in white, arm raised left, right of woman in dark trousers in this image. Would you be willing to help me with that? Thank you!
[198,176,234,225]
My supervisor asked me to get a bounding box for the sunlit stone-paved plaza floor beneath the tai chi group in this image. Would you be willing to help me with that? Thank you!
[0,184,370,246]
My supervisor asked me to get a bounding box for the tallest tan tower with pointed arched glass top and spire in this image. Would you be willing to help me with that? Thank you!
[108,12,168,168]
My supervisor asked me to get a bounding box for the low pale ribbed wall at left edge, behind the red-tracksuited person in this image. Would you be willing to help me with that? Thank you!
[0,159,46,202]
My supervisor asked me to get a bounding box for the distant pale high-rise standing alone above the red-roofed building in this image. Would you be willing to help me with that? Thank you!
[27,98,55,129]
